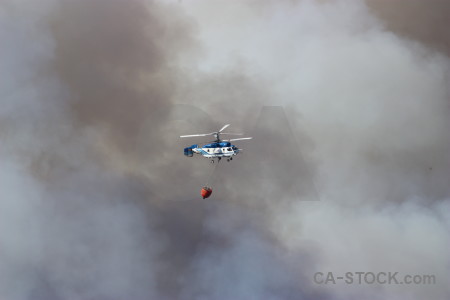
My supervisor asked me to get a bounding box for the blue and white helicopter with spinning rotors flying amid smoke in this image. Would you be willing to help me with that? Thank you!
[180,124,252,163]
